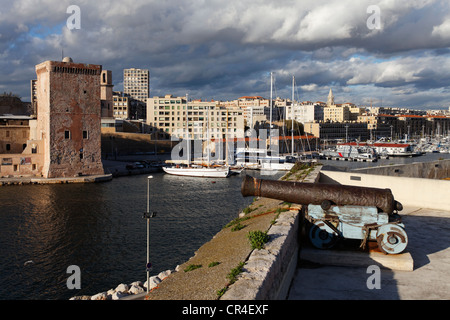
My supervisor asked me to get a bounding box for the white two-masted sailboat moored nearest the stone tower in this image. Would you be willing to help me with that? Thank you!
[163,95,230,178]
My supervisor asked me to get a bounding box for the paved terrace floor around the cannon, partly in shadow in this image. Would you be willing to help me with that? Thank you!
[288,207,450,300]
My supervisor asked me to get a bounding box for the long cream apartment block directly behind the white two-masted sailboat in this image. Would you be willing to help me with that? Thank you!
[147,95,244,140]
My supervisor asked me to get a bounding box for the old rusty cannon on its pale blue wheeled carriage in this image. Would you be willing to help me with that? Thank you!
[241,176,408,254]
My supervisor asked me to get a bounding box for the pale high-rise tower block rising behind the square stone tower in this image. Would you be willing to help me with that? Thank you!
[123,68,150,103]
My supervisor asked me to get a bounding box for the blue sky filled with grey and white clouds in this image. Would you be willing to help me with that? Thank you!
[0,0,450,109]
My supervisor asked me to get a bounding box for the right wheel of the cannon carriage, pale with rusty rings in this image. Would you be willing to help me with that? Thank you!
[377,224,408,254]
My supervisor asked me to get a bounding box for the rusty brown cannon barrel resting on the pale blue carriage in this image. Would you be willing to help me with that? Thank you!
[241,176,403,214]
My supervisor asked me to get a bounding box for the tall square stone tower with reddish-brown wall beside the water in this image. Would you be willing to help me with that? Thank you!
[36,58,104,178]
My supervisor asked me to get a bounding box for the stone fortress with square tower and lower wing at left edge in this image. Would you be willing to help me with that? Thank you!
[0,57,107,178]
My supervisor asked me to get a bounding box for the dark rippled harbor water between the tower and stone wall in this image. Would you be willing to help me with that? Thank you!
[0,154,450,300]
